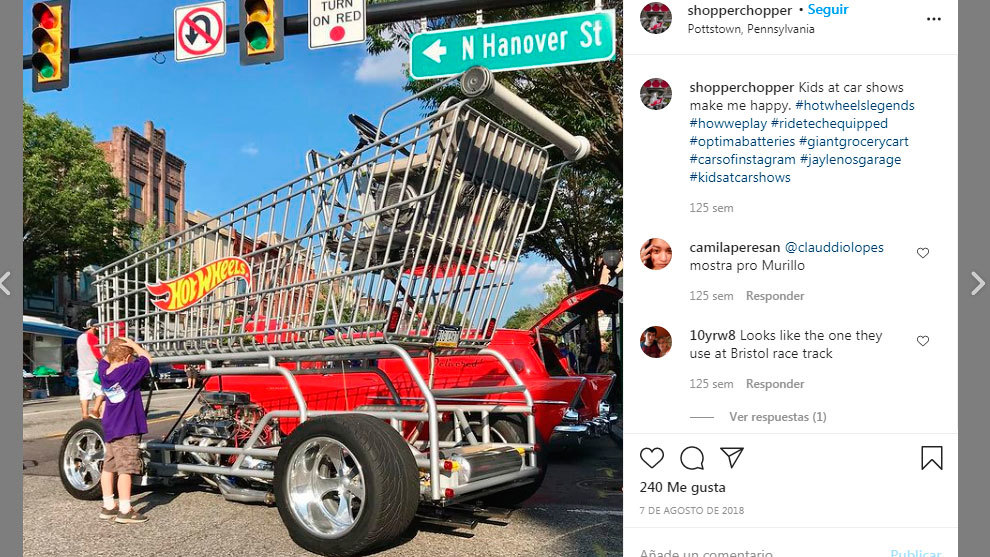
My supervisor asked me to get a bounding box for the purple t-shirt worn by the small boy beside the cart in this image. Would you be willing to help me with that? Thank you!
[97,356,151,443]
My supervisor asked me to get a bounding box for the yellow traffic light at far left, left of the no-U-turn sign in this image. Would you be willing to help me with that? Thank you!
[31,0,69,92]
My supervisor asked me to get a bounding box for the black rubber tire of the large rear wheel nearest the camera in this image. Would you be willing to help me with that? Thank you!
[275,414,419,557]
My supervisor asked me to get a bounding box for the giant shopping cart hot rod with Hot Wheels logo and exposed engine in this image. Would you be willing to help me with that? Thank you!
[59,67,590,555]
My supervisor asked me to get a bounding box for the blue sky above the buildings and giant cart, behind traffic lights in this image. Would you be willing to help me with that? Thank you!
[22,0,560,320]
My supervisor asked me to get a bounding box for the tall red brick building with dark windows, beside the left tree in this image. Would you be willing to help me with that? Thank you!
[96,120,186,245]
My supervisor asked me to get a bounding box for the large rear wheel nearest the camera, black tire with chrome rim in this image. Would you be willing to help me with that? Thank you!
[275,414,419,557]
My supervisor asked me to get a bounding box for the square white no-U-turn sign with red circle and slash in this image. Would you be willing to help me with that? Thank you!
[175,2,227,62]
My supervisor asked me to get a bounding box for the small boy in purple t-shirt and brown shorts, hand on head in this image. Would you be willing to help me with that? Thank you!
[99,337,151,524]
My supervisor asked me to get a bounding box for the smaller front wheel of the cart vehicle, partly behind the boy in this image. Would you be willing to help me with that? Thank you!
[58,418,106,501]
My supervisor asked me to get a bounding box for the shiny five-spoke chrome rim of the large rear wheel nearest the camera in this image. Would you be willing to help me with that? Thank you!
[286,437,365,539]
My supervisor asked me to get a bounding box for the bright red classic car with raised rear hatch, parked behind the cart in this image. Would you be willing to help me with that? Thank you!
[205,285,622,446]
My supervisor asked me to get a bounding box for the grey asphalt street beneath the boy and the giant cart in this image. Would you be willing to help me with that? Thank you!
[23,389,622,557]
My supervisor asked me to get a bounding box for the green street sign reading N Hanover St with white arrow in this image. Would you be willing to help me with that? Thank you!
[409,10,615,79]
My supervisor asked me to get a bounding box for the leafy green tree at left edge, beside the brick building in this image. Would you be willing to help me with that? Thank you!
[23,103,128,289]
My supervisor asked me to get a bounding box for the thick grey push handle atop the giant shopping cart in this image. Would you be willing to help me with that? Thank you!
[461,66,591,161]
